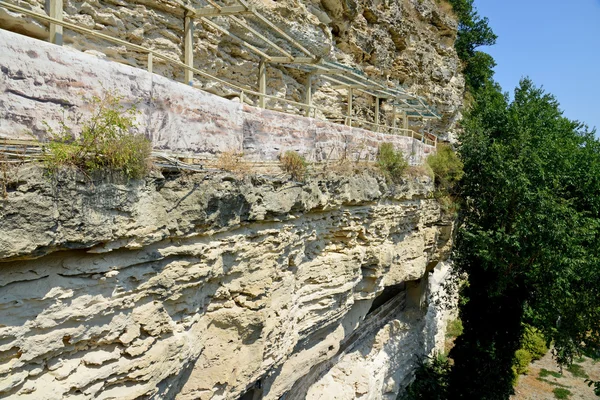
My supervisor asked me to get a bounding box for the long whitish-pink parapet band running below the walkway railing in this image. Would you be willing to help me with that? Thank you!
[0,31,434,164]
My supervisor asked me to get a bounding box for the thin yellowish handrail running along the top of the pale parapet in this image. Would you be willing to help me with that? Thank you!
[0,0,437,147]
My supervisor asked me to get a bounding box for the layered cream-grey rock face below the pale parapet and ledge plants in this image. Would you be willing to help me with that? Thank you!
[0,167,451,399]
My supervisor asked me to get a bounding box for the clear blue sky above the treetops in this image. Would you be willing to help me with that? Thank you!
[474,0,600,135]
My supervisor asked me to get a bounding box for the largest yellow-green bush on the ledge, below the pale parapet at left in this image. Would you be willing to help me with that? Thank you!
[44,93,152,179]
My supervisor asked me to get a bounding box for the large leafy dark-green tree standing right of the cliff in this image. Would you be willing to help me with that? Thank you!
[450,80,600,400]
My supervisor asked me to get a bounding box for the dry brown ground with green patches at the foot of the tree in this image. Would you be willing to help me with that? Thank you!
[511,352,600,400]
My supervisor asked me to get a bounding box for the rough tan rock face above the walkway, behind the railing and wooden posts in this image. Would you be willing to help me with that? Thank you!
[0,0,464,136]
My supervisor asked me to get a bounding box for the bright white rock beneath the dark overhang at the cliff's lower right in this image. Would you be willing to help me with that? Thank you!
[302,262,457,400]
